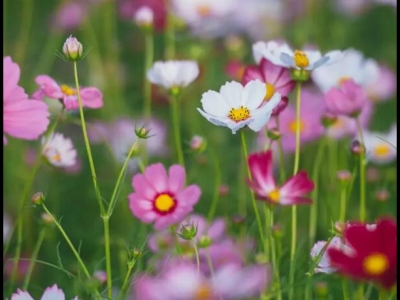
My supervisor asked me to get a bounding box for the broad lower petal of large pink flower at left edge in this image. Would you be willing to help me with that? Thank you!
[3,100,49,140]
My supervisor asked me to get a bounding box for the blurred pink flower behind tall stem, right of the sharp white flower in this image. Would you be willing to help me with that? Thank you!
[258,89,325,152]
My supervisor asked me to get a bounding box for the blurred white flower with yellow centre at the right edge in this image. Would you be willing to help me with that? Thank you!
[363,125,397,165]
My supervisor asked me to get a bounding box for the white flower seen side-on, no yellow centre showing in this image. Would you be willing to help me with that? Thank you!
[147,60,199,89]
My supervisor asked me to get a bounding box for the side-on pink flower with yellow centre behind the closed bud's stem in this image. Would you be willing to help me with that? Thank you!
[32,75,103,110]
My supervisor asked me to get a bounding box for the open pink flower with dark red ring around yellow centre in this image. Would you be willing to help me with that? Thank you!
[129,163,201,230]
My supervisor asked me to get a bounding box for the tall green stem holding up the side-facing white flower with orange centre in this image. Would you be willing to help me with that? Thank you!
[289,81,301,300]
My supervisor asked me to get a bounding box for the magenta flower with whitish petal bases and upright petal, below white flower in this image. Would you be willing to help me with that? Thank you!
[247,150,314,205]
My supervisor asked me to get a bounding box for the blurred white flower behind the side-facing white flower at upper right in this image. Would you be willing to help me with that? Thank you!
[311,49,379,93]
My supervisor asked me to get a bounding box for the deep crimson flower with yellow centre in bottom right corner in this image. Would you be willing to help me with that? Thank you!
[328,219,397,289]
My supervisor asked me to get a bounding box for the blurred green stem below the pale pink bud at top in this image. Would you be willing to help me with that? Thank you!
[143,29,154,120]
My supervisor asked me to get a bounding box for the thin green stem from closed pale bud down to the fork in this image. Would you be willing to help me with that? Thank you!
[74,61,104,214]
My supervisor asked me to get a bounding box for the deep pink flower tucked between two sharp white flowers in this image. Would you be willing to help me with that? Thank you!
[242,58,296,101]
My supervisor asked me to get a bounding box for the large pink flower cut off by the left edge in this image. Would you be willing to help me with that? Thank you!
[3,56,50,144]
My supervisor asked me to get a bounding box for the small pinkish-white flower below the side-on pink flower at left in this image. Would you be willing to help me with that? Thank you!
[42,133,77,168]
